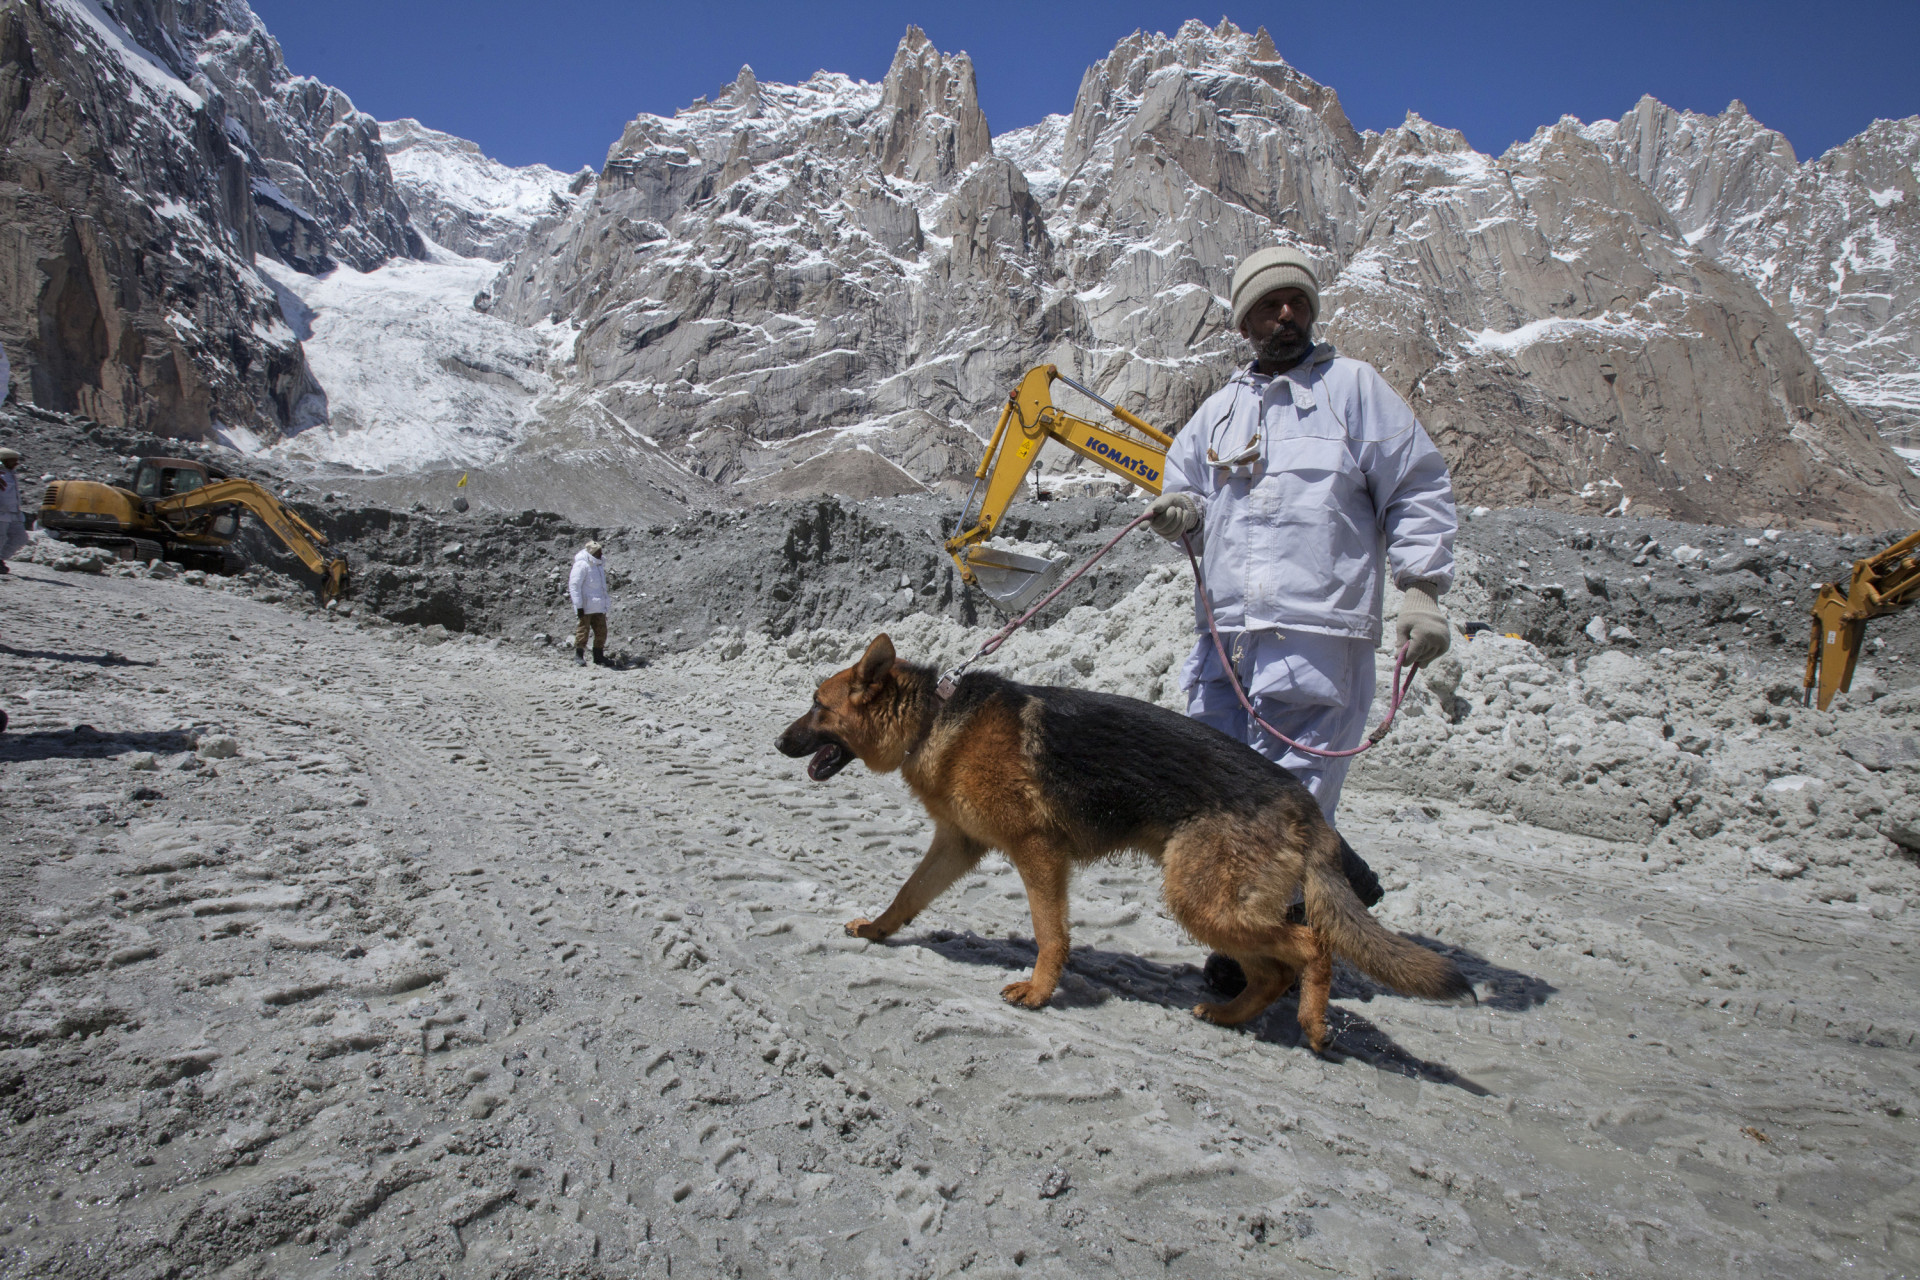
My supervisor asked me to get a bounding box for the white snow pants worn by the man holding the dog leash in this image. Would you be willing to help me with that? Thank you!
[1187,637,1373,823]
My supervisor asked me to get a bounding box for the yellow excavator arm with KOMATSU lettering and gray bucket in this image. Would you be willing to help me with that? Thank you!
[947,365,1173,614]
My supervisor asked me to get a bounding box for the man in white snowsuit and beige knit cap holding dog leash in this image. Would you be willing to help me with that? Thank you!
[1148,248,1459,924]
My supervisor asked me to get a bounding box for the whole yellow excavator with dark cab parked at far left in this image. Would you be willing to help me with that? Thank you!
[40,459,348,601]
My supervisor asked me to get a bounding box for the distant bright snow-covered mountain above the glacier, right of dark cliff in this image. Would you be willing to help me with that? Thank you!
[380,119,593,263]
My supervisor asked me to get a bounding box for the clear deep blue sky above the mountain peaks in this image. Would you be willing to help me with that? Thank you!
[252,0,1920,169]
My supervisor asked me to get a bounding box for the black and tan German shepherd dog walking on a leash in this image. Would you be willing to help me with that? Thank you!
[778,635,1473,1052]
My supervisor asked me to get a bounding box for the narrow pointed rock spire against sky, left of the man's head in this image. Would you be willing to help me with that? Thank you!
[879,27,993,188]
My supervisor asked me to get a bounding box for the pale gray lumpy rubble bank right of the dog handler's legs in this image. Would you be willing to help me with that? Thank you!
[1352,635,1920,913]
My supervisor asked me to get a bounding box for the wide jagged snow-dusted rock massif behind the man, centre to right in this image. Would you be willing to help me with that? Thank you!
[482,23,1920,526]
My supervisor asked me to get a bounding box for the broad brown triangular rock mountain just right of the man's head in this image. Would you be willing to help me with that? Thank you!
[1327,119,1896,528]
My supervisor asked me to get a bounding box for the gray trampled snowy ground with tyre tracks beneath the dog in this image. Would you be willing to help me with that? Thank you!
[0,564,1916,1278]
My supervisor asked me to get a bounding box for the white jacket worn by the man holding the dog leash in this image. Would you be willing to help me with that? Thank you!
[1165,344,1459,643]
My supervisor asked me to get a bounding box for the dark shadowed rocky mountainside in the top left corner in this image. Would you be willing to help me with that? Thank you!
[0,0,422,439]
